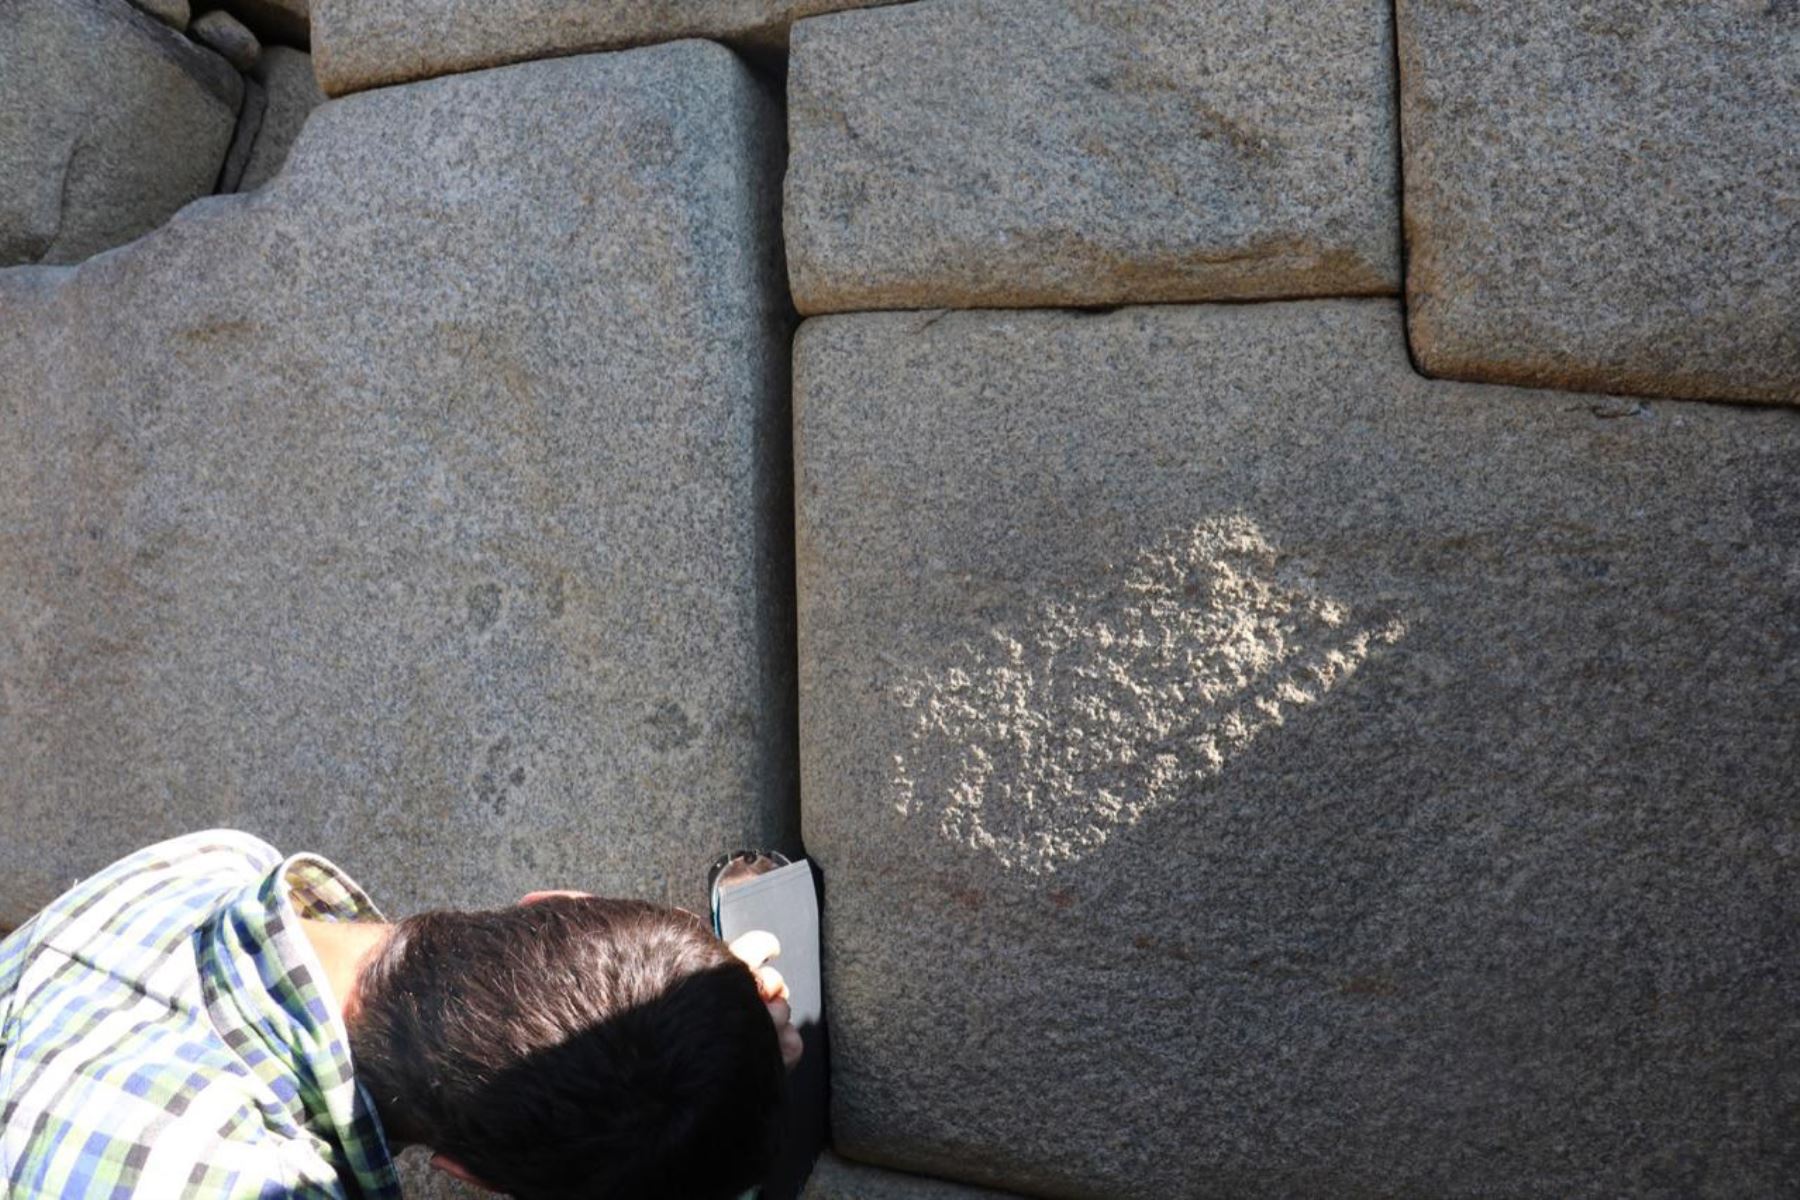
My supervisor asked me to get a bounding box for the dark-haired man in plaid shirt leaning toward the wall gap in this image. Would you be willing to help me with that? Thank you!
[0,831,799,1200]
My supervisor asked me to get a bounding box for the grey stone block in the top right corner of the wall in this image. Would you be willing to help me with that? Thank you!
[1399,0,1800,403]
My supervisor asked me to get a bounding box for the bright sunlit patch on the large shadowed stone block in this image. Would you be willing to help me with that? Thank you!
[893,515,1406,874]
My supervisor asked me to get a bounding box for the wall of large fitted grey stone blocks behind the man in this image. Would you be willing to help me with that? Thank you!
[0,0,1800,1200]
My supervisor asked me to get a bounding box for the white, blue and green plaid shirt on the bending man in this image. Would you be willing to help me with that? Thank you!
[0,831,400,1200]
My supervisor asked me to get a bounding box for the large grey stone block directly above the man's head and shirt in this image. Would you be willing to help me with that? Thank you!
[0,43,796,919]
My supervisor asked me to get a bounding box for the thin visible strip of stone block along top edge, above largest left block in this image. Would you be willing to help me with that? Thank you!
[313,0,895,95]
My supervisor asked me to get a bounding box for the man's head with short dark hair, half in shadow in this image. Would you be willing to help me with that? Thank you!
[346,896,785,1200]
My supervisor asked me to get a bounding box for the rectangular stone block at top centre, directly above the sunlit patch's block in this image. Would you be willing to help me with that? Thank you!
[785,0,1400,313]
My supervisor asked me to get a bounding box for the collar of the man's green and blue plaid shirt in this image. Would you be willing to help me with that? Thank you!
[196,855,400,1200]
